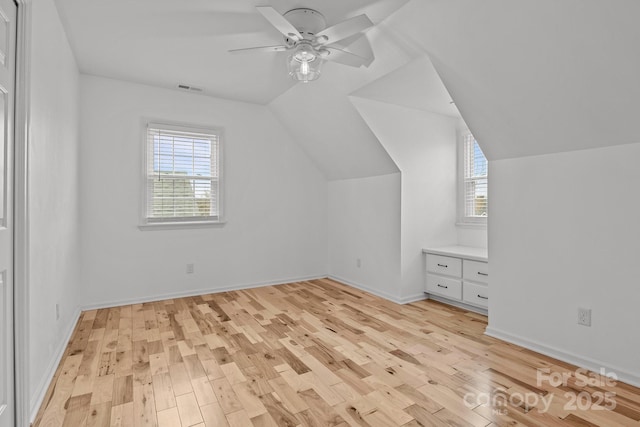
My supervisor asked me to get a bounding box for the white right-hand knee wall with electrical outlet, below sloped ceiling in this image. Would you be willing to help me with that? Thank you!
[488,144,640,385]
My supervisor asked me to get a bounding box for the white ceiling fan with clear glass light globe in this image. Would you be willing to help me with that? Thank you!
[229,6,373,83]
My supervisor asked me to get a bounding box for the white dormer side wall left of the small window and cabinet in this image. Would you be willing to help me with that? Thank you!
[352,97,457,301]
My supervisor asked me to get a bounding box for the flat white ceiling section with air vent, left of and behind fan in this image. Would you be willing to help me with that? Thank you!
[56,0,407,104]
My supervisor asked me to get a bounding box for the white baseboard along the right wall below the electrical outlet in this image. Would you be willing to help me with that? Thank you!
[485,327,640,387]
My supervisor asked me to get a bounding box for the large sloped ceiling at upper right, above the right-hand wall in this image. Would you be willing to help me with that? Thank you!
[385,0,640,160]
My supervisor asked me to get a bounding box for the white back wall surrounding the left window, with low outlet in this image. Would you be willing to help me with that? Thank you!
[80,76,327,306]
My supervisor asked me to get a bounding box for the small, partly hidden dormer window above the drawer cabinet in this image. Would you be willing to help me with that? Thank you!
[460,132,489,224]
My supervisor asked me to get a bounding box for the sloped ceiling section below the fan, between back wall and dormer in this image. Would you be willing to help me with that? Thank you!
[270,28,418,180]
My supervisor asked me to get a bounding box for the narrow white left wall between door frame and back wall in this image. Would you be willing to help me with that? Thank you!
[28,0,80,414]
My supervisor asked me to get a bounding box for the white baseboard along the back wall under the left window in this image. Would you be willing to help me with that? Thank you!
[82,275,327,311]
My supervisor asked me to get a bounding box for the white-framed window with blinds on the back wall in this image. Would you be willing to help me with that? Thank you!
[144,123,222,225]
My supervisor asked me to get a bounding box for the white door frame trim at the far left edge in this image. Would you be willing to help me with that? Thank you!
[13,0,32,427]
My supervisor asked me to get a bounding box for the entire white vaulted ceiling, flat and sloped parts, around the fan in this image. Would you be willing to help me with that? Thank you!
[56,0,640,179]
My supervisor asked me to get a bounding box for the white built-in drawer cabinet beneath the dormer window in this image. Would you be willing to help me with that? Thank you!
[422,246,489,314]
